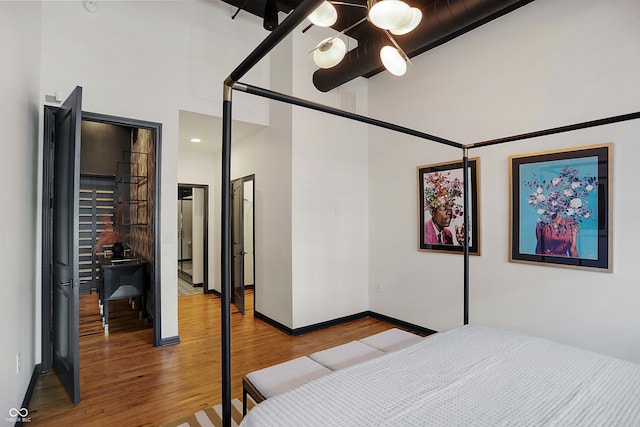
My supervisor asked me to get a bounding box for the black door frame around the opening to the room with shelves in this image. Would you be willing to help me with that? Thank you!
[41,105,164,372]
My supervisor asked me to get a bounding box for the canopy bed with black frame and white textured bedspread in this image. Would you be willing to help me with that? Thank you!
[220,0,640,427]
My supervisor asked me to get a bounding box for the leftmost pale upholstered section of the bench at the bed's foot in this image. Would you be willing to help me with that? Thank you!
[242,356,331,415]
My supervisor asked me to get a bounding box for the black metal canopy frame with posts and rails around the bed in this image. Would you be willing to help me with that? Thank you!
[221,0,640,427]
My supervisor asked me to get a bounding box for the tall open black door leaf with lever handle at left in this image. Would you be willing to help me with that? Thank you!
[52,87,82,404]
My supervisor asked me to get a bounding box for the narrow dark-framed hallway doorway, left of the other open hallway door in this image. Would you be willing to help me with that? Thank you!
[177,184,209,296]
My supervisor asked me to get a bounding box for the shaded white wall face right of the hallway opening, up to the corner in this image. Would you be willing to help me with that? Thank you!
[230,34,292,327]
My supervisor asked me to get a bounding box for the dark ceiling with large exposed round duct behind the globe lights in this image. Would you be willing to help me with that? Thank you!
[222,0,533,92]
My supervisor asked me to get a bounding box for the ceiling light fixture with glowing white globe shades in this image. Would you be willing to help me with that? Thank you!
[305,0,422,76]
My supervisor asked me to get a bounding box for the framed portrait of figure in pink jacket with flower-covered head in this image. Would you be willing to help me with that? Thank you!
[417,158,480,255]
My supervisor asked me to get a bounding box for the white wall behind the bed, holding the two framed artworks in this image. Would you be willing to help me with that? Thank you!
[369,0,640,362]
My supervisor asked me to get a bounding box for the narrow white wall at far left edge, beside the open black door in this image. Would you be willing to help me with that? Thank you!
[0,2,42,419]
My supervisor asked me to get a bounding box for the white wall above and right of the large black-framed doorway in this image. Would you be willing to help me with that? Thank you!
[41,1,268,338]
